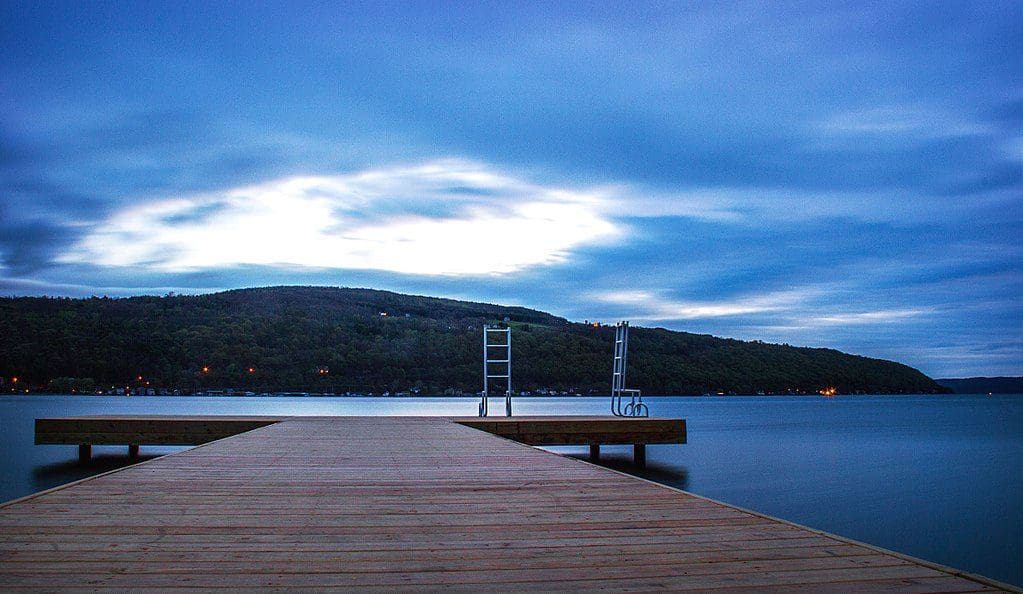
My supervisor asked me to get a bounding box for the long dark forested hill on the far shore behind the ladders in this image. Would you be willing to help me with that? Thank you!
[0,287,948,395]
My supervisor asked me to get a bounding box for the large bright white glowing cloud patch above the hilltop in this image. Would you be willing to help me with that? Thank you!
[57,159,621,275]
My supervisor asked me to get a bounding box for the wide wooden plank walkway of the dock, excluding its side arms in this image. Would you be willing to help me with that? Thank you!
[0,417,997,593]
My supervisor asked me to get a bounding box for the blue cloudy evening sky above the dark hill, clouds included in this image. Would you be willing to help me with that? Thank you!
[0,0,1023,377]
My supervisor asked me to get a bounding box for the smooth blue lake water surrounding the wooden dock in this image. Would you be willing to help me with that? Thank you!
[0,395,1023,585]
